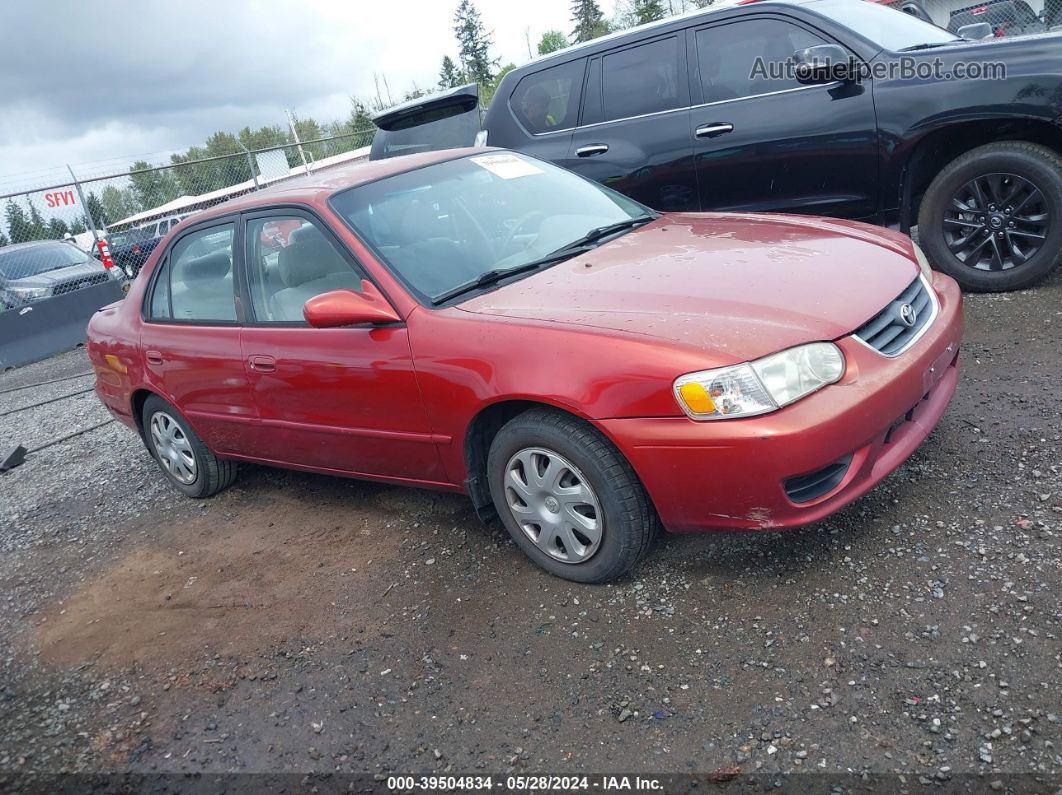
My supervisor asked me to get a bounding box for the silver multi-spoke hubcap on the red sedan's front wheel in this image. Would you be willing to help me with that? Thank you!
[504,447,604,564]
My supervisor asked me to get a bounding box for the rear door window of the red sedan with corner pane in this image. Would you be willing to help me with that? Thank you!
[149,224,236,323]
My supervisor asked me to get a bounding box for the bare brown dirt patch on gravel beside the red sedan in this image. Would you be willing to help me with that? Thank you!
[37,484,448,667]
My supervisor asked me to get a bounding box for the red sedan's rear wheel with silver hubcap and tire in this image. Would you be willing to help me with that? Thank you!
[141,395,237,499]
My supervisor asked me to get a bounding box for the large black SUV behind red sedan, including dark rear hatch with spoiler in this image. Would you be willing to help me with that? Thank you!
[372,0,1062,291]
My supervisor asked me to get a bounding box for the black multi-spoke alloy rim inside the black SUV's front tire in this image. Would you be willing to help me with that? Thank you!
[944,174,1051,271]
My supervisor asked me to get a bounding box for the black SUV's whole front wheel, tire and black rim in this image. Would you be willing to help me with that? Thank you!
[919,141,1062,292]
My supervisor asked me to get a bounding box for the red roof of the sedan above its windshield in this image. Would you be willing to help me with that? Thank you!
[184,146,480,224]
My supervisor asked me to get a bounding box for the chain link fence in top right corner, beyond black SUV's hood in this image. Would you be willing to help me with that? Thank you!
[879,0,1062,38]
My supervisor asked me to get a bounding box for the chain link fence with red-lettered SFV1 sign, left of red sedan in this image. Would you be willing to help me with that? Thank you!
[0,128,374,313]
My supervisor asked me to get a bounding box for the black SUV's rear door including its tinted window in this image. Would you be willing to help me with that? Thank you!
[563,33,699,210]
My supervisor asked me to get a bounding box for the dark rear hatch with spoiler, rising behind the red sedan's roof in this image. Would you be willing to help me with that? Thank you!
[369,83,481,160]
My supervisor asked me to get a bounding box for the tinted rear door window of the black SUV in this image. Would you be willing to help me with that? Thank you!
[601,36,686,121]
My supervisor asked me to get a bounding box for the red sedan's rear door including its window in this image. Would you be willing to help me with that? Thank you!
[140,219,258,455]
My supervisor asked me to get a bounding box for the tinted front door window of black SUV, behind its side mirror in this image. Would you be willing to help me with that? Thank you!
[697,19,826,102]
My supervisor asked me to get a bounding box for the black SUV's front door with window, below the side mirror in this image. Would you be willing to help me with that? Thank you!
[687,17,878,218]
